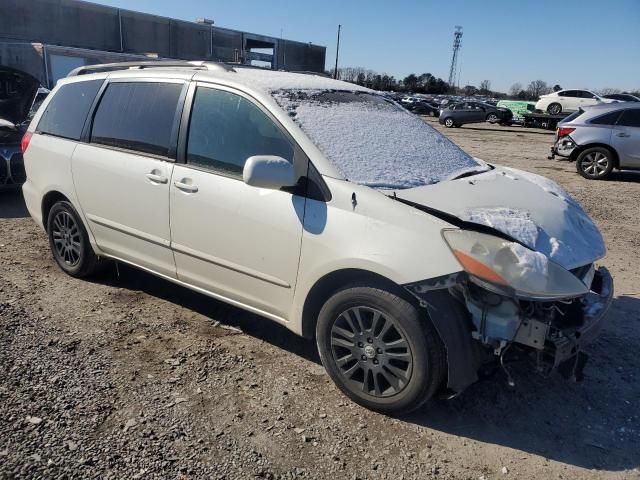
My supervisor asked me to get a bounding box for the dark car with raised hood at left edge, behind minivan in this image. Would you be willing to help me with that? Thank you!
[0,66,48,190]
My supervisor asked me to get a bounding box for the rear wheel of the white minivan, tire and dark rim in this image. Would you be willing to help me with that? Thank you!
[47,201,100,278]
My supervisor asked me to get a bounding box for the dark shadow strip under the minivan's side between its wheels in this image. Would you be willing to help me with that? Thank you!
[90,263,320,364]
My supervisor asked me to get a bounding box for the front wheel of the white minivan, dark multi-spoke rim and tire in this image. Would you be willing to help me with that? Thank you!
[316,286,446,415]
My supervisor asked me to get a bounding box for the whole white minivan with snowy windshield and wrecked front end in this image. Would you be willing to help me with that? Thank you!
[23,62,613,414]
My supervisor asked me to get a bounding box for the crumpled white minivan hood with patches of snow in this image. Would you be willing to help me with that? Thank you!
[396,167,606,269]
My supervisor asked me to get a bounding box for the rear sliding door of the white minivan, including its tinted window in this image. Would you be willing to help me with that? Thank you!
[72,81,185,277]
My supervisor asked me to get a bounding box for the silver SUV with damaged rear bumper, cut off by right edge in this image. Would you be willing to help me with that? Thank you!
[551,102,640,180]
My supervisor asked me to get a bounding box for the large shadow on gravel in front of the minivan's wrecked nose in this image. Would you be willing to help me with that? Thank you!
[403,296,640,471]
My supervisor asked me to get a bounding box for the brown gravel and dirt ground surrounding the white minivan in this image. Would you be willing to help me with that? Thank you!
[0,120,640,480]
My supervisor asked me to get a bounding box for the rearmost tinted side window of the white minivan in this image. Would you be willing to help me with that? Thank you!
[36,80,103,140]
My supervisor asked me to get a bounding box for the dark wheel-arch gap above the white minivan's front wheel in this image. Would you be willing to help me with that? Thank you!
[301,268,417,339]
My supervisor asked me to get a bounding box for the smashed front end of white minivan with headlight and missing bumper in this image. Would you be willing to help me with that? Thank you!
[405,230,613,392]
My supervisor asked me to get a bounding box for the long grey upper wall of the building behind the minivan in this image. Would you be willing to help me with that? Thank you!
[0,0,326,72]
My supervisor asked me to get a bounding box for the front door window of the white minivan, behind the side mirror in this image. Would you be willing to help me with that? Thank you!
[187,88,294,177]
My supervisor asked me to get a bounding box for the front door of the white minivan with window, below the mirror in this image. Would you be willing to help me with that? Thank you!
[170,85,306,319]
